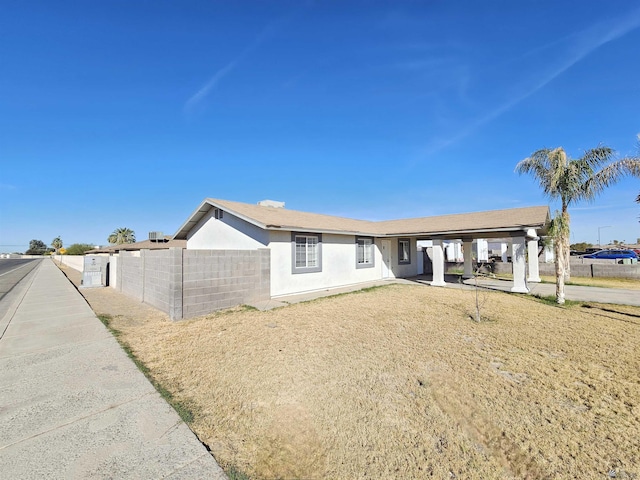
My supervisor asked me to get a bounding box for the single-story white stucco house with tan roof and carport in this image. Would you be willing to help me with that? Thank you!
[172,198,549,298]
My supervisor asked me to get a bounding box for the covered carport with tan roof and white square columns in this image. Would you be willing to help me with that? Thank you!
[385,206,550,293]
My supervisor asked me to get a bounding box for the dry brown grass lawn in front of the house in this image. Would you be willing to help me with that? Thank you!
[65,264,640,479]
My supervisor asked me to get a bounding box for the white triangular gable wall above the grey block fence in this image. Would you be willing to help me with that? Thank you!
[187,210,269,250]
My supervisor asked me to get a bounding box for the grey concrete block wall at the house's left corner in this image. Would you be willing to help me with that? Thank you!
[111,248,271,320]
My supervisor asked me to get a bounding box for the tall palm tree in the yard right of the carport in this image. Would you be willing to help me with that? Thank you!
[516,146,640,304]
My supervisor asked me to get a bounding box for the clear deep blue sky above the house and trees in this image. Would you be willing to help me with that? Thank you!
[0,0,640,252]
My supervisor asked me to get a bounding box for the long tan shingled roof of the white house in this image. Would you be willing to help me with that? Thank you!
[173,198,549,239]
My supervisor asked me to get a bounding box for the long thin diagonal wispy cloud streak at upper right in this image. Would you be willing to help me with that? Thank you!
[422,9,640,156]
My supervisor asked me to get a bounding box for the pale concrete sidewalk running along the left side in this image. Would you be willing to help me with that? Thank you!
[0,260,226,479]
